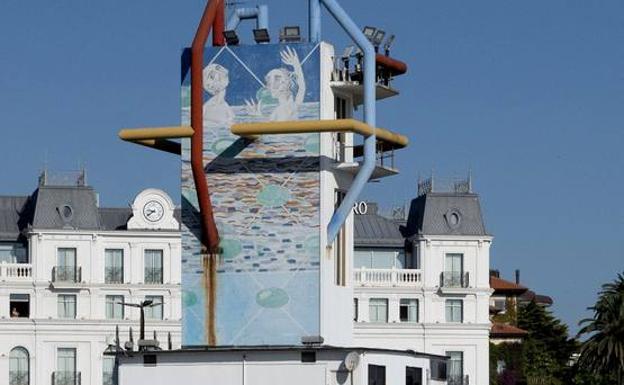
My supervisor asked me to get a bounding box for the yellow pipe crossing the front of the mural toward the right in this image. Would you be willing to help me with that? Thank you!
[230,119,409,150]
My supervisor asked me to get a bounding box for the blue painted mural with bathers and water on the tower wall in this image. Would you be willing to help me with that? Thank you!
[181,44,320,345]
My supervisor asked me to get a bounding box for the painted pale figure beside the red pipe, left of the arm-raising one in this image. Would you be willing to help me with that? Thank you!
[203,63,234,128]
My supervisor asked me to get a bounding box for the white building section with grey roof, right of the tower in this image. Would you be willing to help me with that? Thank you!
[354,192,492,385]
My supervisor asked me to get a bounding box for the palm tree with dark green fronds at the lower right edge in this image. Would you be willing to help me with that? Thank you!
[578,273,624,385]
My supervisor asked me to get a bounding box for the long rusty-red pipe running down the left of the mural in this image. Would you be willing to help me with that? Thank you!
[191,0,224,254]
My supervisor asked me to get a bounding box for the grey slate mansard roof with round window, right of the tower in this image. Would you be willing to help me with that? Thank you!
[406,193,488,237]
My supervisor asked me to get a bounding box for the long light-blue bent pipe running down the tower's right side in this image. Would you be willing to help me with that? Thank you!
[320,0,376,246]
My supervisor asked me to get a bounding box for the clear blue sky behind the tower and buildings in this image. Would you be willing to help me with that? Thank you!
[0,0,624,330]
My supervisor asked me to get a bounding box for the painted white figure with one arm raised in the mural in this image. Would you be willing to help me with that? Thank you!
[245,47,305,121]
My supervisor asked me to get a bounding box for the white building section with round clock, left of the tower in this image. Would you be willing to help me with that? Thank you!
[0,178,181,385]
